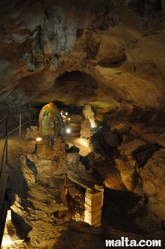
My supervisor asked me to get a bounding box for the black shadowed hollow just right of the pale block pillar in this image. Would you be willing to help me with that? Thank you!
[102,188,145,234]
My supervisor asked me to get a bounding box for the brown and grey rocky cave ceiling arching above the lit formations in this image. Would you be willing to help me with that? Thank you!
[0,0,165,120]
